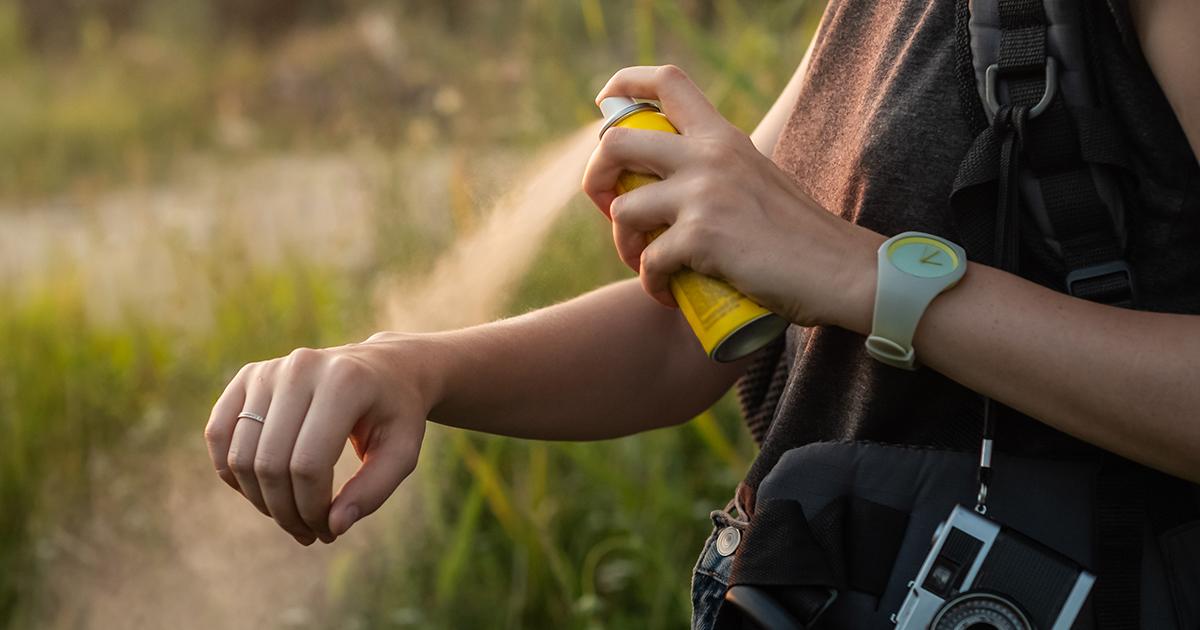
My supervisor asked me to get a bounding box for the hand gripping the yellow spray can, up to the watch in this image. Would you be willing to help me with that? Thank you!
[583,66,884,330]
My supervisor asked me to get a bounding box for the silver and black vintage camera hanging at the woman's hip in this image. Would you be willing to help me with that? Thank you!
[892,505,1096,630]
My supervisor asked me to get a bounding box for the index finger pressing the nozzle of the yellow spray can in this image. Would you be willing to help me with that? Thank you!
[596,65,728,136]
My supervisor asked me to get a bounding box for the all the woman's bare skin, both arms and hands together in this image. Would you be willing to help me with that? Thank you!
[205,0,1200,545]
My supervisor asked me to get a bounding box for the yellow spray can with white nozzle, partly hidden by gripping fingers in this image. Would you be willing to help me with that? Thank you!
[600,96,788,361]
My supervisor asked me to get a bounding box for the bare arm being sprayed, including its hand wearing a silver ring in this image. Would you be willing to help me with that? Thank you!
[205,52,816,545]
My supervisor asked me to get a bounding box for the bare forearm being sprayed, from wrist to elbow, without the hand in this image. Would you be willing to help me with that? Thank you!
[424,280,744,439]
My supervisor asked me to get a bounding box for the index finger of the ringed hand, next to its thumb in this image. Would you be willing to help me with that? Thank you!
[292,361,374,540]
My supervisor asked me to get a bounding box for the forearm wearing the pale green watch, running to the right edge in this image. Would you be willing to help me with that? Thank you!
[850,243,1200,480]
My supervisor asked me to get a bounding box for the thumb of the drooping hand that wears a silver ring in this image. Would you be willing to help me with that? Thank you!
[329,422,425,535]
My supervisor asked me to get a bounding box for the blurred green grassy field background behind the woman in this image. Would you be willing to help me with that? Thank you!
[0,0,822,629]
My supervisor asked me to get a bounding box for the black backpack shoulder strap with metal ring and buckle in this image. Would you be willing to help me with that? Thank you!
[952,0,1135,307]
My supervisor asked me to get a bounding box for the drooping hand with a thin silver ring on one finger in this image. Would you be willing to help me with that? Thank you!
[204,334,430,545]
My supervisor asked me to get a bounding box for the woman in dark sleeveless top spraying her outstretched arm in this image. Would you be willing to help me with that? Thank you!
[206,0,1200,626]
